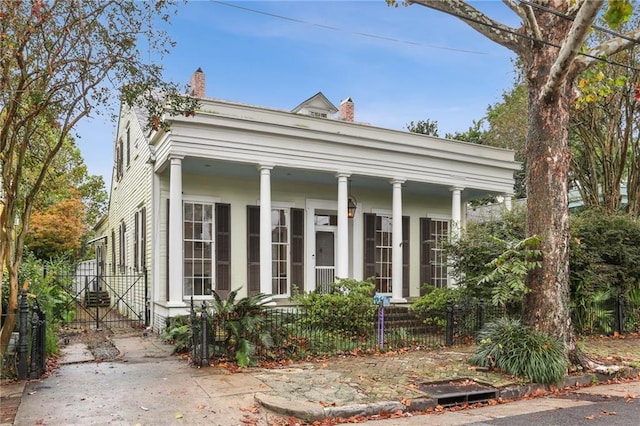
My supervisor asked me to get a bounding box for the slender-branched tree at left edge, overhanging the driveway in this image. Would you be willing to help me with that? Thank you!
[0,0,197,354]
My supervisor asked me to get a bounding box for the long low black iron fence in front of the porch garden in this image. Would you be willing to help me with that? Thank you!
[189,292,640,366]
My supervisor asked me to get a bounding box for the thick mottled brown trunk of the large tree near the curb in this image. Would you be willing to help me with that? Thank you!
[523,37,576,359]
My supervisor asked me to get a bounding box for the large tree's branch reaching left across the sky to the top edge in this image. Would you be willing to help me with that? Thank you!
[408,0,526,54]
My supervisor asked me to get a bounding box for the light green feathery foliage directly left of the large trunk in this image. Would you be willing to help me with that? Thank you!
[479,236,542,314]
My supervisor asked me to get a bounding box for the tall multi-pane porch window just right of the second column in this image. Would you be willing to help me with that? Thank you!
[271,209,289,294]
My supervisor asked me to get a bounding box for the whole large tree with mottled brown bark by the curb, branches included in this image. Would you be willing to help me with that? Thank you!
[387,0,640,362]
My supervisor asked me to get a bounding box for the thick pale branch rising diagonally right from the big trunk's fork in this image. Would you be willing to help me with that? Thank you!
[540,0,604,99]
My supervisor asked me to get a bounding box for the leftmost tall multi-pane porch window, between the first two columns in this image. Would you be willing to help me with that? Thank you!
[183,202,213,296]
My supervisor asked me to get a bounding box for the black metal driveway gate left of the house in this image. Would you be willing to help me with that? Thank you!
[62,262,150,329]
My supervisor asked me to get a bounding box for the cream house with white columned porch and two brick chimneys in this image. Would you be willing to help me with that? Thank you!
[97,69,520,329]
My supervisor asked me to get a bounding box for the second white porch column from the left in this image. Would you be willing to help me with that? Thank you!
[258,164,273,294]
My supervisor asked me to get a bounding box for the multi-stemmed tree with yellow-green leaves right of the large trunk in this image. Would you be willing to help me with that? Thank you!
[569,13,640,218]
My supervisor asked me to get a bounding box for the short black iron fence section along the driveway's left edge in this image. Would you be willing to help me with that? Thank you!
[14,291,47,380]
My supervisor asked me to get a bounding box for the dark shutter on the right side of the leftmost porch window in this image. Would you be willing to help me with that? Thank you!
[215,204,231,299]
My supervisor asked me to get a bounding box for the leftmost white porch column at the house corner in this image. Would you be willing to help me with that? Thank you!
[167,157,185,307]
